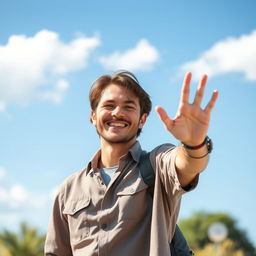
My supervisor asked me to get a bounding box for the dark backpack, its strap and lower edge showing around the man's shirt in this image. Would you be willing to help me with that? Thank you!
[138,151,194,256]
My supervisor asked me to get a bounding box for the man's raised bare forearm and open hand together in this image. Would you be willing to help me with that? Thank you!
[156,73,218,187]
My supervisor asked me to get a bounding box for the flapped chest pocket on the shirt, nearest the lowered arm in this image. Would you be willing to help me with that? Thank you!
[63,197,91,244]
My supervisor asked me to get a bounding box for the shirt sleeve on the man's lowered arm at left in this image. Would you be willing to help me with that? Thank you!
[44,186,73,256]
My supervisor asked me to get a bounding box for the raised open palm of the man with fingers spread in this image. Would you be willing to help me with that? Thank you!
[156,73,218,146]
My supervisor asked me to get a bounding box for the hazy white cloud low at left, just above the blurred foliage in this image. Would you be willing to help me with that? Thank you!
[0,170,58,230]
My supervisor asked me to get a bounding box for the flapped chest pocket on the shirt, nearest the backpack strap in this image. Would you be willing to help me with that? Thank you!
[116,179,149,221]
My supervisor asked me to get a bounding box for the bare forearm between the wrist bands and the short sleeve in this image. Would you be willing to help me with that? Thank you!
[175,145,209,187]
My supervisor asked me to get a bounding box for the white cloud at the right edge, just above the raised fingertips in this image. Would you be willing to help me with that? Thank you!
[181,31,256,81]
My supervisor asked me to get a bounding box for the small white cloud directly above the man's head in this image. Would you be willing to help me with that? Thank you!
[100,39,159,71]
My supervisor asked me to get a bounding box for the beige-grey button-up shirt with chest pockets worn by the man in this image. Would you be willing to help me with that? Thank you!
[45,142,198,256]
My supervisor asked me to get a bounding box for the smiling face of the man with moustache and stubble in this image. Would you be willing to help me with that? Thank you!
[91,84,147,145]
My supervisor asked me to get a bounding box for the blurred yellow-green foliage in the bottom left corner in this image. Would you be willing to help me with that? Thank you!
[0,222,45,256]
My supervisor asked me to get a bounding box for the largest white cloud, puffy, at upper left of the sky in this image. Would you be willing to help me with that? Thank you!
[0,30,100,112]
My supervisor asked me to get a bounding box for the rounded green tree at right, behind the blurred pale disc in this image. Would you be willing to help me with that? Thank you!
[179,212,256,256]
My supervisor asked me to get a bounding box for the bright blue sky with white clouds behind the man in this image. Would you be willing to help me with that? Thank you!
[0,0,256,248]
